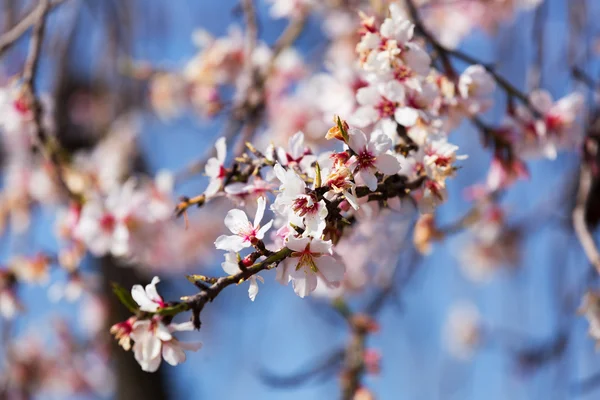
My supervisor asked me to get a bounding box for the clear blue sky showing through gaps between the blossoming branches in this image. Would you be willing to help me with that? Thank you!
[7,0,600,400]
